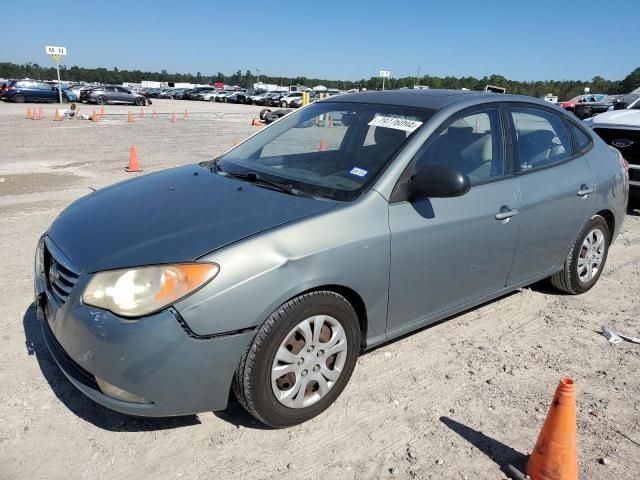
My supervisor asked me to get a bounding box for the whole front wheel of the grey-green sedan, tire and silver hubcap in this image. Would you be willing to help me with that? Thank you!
[233,291,360,428]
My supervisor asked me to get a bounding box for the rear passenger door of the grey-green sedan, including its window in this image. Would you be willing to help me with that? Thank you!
[508,104,596,285]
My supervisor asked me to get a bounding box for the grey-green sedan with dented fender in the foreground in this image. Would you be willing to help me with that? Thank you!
[35,90,628,427]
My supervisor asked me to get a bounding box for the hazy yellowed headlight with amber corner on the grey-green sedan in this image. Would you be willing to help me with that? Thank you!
[82,263,220,317]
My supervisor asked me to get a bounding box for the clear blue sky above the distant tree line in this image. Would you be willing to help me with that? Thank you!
[0,0,640,80]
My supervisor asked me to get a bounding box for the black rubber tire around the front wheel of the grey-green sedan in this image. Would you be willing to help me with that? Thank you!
[233,291,360,428]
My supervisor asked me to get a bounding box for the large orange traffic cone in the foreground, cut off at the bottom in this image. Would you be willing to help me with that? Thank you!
[527,378,578,480]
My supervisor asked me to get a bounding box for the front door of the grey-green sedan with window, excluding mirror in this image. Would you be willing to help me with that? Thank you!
[387,107,520,332]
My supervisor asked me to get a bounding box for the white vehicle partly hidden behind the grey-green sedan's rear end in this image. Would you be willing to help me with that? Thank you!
[585,107,640,197]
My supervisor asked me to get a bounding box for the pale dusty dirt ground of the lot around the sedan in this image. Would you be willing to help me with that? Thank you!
[0,100,640,480]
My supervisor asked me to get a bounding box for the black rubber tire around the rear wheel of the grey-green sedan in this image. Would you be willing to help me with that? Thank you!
[551,215,611,295]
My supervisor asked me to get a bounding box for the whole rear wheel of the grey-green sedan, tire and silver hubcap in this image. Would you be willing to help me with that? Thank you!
[551,215,611,295]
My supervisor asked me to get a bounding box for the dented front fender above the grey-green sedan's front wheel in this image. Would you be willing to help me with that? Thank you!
[175,191,390,343]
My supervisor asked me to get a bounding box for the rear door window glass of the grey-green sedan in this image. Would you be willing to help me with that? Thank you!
[511,107,572,172]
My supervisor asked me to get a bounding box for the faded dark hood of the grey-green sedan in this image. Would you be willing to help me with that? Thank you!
[48,165,337,273]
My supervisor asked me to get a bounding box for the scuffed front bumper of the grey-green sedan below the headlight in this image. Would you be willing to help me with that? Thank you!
[35,238,254,417]
